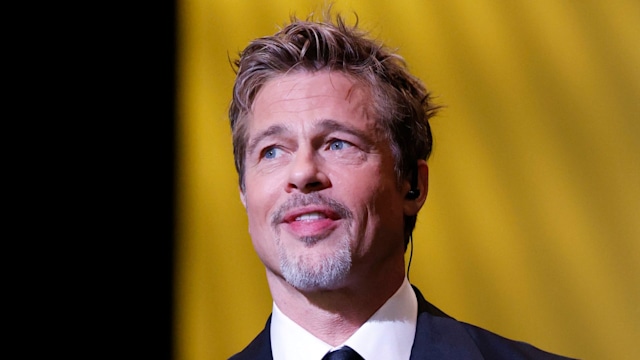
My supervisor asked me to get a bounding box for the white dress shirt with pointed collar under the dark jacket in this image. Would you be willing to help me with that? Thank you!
[271,278,418,360]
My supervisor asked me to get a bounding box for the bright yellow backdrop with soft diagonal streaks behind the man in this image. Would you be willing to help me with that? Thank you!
[175,0,640,360]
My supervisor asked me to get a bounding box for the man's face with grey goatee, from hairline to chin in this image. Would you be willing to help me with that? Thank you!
[242,72,408,291]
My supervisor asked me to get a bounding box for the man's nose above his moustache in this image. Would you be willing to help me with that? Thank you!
[287,149,331,194]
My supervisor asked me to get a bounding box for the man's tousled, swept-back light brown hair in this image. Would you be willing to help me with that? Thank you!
[229,11,438,248]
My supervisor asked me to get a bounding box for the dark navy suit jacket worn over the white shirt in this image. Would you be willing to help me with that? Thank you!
[230,287,567,360]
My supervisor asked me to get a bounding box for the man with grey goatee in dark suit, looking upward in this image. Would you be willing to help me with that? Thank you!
[229,11,572,360]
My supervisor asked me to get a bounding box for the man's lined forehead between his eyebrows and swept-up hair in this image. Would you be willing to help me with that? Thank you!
[249,71,373,128]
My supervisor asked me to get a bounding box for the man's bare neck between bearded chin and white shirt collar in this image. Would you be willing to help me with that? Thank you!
[267,259,405,346]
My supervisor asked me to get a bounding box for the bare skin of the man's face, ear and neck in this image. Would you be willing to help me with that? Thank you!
[241,71,428,346]
